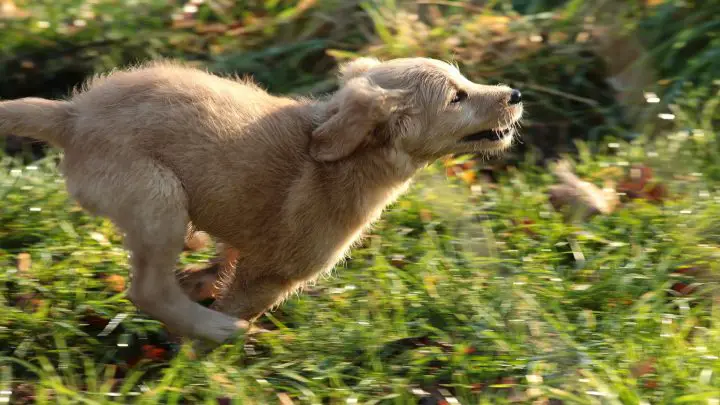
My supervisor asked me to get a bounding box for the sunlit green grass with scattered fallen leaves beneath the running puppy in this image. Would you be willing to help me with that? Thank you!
[0,105,720,404]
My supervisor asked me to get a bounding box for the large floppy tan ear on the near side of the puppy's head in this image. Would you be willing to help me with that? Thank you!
[310,77,407,162]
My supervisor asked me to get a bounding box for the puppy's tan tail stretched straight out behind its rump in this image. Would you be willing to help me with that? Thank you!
[0,97,71,147]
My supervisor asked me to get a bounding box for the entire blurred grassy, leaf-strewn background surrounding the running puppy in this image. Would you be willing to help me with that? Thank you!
[0,0,720,405]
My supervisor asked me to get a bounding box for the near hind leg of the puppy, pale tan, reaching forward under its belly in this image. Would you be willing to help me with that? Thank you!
[65,156,247,342]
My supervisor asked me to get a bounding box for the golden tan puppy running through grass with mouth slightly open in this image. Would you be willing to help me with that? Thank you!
[0,58,523,342]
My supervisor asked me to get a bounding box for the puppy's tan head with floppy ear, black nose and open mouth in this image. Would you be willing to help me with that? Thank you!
[310,58,523,162]
